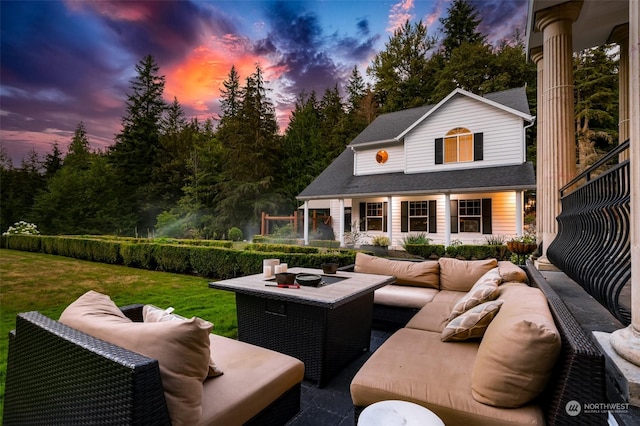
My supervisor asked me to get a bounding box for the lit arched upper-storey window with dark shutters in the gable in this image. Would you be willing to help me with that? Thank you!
[435,127,483,164]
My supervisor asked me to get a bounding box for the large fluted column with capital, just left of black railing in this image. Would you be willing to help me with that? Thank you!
[536,1,582,264]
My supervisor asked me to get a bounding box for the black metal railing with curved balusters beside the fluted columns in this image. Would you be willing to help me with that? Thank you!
[547,140,631,325]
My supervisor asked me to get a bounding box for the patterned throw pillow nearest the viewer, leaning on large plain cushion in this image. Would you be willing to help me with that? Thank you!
[440,300,503,342]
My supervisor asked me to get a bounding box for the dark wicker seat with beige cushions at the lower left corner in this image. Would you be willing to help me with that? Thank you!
[3,292,304,426]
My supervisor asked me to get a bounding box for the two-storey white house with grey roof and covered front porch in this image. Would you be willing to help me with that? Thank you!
[297,88,536,248]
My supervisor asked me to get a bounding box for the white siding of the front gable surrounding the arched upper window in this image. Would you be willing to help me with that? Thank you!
[405,96,525,173]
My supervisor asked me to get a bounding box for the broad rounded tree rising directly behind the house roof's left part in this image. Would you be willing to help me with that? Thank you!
[367,20,435,112]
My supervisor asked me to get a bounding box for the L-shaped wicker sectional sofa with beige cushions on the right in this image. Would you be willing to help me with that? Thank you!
[351,254,606,426]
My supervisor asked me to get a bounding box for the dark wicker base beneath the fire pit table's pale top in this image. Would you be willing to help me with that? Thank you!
[236,292,373,387]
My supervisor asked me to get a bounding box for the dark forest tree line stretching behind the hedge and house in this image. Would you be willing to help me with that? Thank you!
[0,0,618,238]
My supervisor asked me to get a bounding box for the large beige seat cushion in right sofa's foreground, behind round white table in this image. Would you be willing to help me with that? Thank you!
[350,328,544,426]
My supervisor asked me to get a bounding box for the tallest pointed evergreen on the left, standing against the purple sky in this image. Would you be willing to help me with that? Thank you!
[110,55,166,231]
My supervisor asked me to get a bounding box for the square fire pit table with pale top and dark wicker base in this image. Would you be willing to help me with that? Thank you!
[209,268,395,386]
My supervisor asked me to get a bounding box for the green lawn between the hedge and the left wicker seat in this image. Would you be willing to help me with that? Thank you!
[0,249,237,419]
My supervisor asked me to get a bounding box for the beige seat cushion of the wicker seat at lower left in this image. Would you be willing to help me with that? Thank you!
[200,334,304,425]
